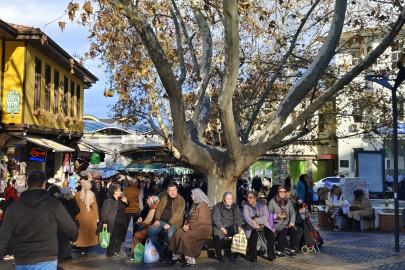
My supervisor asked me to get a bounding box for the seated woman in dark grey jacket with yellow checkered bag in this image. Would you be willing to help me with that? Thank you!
[212,192,242,262]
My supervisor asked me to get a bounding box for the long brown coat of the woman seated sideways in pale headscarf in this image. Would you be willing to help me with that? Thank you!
[168,202,212,258]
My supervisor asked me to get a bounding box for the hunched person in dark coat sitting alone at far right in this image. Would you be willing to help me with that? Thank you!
[347,189,374,231]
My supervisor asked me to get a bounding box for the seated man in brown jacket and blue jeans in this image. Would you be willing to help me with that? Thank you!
[148,183,186,261]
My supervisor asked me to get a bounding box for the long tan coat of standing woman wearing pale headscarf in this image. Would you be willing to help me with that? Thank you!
[75,189,98,247]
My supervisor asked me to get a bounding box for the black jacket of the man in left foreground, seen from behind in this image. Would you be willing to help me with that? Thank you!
[0,189,79,265]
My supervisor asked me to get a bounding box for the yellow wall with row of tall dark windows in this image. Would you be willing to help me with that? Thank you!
[24,44,83,125]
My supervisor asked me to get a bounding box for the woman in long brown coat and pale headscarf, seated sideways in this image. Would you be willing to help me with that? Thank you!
[168,188,212,267]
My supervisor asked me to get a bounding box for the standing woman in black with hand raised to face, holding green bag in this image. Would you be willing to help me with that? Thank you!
[101,184,129,257]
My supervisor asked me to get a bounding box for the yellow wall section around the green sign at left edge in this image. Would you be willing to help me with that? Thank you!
[0,41,25,124]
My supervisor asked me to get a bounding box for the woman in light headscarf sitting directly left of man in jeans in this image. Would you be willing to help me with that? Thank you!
[131,196,160,258]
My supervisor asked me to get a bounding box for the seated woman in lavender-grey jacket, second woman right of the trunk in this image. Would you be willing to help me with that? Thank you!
[238,191,275,262]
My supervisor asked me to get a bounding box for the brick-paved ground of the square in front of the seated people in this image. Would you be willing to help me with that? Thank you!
[0,218,405,270]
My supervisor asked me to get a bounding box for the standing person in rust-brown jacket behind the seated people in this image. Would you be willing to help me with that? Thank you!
[124,179,141,237]
